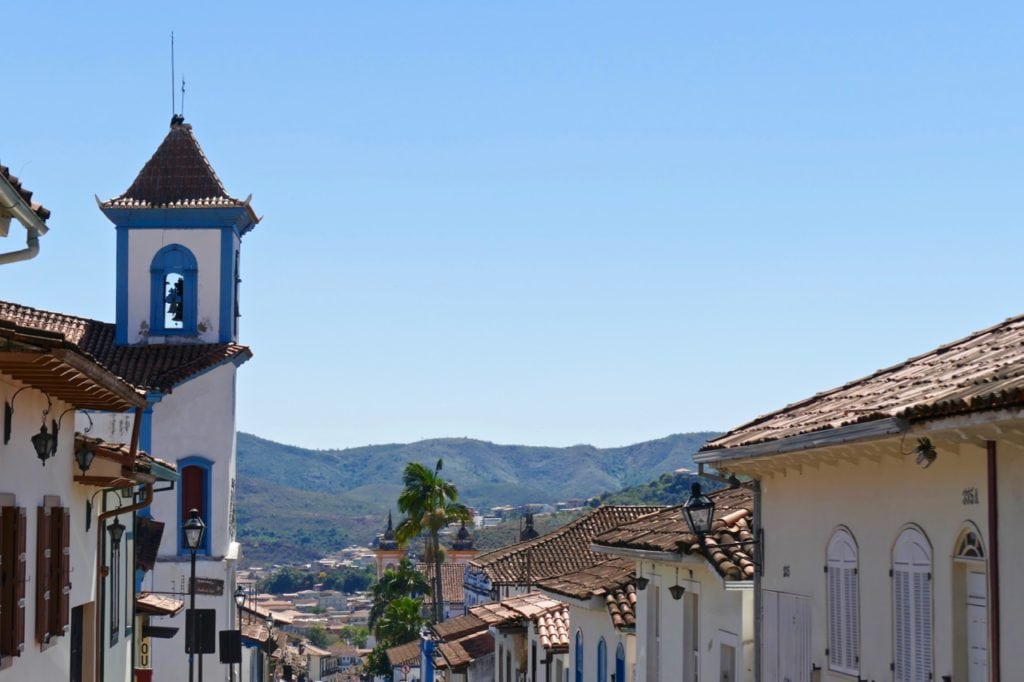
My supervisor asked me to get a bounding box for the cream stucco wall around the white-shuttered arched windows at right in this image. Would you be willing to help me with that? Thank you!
[724,424,1024,682]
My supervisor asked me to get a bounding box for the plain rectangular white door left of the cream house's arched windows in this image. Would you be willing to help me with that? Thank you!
[761,590,811,682]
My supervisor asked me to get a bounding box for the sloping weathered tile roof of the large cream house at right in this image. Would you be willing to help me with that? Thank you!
[702,316,1024,451]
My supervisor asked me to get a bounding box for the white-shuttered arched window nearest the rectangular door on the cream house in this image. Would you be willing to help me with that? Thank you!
[825,528,860,675]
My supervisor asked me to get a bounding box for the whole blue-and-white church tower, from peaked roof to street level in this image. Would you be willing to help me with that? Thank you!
[97,116,259,682]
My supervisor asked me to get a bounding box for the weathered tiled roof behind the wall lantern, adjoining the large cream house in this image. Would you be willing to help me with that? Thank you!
[593,487,754,577]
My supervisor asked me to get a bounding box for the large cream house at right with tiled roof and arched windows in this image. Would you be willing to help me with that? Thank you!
[696,317,1024,682]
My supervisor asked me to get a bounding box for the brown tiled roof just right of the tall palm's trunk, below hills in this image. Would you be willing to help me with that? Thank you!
[469,506,662,585]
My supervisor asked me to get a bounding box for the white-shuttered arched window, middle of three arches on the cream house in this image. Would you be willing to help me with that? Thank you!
[893,527,933,682]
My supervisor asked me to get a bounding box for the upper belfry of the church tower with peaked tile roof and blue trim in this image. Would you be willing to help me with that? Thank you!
[97,115,259,345]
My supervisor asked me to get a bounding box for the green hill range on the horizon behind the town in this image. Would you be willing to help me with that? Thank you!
[238,432,716,563]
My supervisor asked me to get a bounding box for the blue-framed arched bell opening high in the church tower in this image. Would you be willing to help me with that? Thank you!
[150,244,199,335]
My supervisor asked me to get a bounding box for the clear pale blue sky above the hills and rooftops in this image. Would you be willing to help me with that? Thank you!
[0,1,1024,447]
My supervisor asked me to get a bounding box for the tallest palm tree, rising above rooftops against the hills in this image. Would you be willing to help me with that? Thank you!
[394,460,469,623]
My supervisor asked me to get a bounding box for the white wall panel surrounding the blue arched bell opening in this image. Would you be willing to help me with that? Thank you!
[128,228,220,343]
